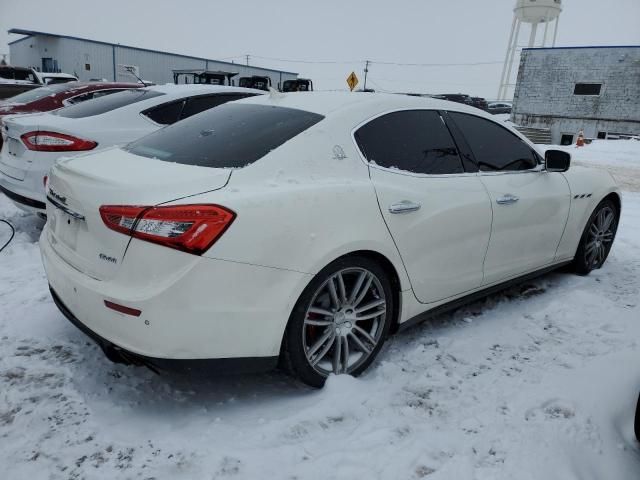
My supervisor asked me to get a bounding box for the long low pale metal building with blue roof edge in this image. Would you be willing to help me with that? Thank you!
[9,28,298,88]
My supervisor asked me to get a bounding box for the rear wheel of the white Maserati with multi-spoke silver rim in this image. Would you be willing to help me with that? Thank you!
[282,256,395,388]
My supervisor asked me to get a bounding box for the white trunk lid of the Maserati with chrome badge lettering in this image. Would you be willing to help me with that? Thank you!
[46,148,231,280]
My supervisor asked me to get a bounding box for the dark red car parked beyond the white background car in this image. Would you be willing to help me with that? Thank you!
[0,82,144,147]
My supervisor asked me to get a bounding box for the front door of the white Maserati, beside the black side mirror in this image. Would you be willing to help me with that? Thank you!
[448,112,570,284]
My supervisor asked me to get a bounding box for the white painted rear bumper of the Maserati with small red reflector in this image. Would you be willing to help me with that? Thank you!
[40,226,310,365]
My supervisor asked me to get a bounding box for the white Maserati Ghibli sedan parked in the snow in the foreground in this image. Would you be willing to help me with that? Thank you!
[40,92,621,386]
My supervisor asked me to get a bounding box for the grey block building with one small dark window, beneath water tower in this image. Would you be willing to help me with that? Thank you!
[511,45,640,144]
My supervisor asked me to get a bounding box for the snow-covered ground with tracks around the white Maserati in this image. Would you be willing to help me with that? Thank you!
[0,142,640,480]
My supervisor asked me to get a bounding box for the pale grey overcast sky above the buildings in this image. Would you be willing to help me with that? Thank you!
[0,0,640,98]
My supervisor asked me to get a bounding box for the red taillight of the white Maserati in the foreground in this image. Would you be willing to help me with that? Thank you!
[100,205,236,255]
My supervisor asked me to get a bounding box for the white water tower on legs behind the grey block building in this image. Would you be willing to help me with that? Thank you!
[498,0,562,100]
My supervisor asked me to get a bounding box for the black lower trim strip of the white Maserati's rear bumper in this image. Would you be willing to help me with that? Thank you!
[50,288,278,374]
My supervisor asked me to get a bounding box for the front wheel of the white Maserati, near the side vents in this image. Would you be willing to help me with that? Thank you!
[573,200,620,275]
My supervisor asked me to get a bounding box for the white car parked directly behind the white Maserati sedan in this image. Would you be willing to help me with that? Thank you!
[0,85,265,215]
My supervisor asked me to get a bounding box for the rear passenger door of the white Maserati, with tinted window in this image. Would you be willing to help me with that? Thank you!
[354,110,491,303]
